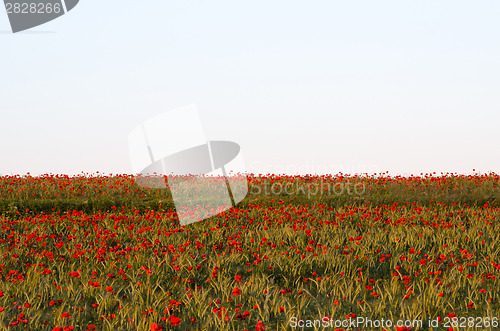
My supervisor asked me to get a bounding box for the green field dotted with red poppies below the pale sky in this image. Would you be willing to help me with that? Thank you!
[0,173,500,331]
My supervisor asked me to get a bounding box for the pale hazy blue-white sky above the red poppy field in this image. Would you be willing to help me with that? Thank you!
[0,0,500,174]
